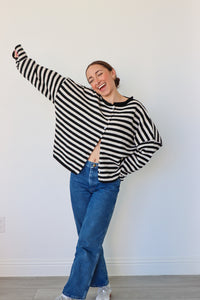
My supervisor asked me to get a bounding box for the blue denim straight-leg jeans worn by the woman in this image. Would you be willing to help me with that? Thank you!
[63,161,120,299]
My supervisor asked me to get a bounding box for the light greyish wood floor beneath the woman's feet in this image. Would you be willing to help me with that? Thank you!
[0,276,200,300]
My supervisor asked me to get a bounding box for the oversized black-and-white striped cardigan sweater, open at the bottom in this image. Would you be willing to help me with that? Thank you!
[12,45,162,182]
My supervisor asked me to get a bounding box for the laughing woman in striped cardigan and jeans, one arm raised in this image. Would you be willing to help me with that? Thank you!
[13,45,162,300]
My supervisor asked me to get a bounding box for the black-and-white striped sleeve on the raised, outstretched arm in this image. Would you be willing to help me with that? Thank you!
[12,45,65,102]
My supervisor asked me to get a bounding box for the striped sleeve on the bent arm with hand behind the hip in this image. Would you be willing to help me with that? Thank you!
[120,105,162,180]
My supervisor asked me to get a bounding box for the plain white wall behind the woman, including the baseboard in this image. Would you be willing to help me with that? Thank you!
[0,0,200,276]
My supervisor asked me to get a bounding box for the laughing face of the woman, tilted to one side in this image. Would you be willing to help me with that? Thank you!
[86,65,116,97]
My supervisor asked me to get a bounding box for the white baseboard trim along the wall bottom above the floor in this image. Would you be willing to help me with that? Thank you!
[0,257,200,277]
